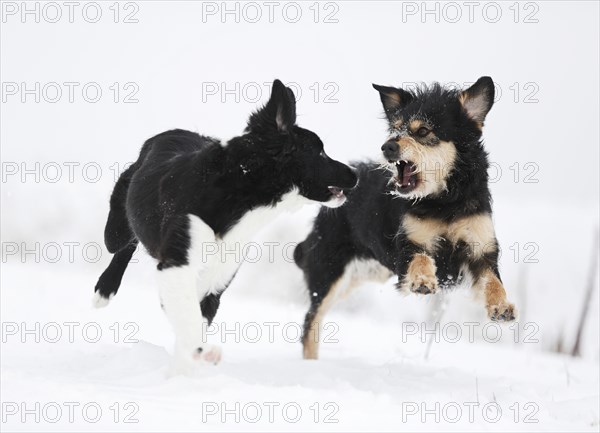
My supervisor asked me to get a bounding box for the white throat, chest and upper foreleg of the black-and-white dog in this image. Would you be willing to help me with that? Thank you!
[188,189,308,294]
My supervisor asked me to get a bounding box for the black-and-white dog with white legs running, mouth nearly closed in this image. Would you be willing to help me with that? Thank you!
[95,80,357,370]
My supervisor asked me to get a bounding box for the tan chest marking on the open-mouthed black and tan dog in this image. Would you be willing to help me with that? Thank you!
[402,213,496,257]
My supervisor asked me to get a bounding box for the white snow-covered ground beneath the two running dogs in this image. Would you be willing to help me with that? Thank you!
[1,203,599,431]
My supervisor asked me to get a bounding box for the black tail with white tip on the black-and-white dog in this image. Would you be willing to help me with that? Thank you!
[93,140,152,308]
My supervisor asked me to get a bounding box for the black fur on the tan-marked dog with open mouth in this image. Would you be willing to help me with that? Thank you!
[294,77,510,348]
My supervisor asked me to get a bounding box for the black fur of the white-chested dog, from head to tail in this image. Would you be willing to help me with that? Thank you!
[95,80,356,314]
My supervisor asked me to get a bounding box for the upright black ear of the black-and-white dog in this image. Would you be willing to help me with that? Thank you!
[247,80,296,134]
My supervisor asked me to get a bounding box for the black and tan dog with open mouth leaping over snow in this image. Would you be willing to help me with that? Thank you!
[294,77,515,359]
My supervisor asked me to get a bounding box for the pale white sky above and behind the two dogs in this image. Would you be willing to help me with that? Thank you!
[1,2,599,237]
